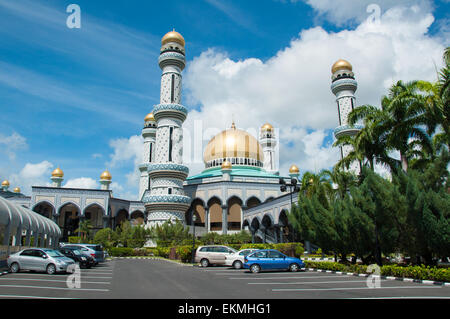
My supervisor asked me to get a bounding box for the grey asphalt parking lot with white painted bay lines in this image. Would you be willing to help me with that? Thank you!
[0,259,450,299]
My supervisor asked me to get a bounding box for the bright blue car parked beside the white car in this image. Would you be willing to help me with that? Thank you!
[244,249,305,273]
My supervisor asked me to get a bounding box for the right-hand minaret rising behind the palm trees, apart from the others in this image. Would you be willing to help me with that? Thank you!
[331,59,362,174]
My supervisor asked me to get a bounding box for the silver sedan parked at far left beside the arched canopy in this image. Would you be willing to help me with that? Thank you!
[7,248,75,275]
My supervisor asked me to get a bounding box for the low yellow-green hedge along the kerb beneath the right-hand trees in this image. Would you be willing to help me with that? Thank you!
[305,261,450,282]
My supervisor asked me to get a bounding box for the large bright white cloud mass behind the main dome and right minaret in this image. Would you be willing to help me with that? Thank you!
[184,1,444,174]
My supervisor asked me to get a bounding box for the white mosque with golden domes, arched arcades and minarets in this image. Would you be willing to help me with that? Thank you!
[0,31,359,243]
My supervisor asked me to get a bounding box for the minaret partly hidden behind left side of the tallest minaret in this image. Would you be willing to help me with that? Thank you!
[139,113,156,200]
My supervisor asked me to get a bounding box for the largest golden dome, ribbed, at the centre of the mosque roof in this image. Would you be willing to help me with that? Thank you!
[203,123,264,165]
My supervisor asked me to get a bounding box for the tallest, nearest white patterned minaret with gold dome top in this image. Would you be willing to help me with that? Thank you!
[142,31,191,227]
